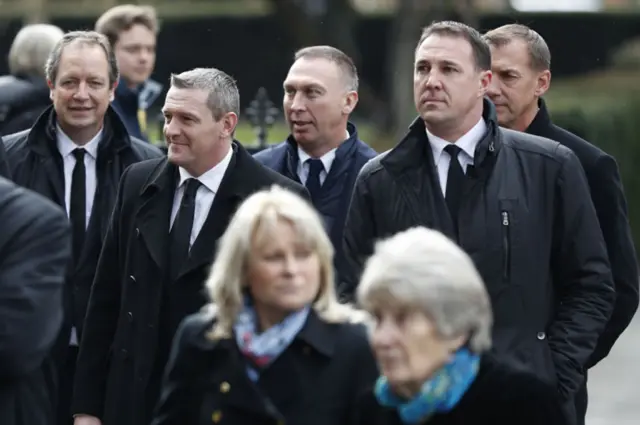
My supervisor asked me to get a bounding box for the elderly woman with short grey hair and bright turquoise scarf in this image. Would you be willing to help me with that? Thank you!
[357,228,565,425]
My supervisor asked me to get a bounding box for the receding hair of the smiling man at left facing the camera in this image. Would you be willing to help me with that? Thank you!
[45,31,120,85]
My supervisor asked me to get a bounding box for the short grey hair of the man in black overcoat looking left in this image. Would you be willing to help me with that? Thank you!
[171,68,240,121]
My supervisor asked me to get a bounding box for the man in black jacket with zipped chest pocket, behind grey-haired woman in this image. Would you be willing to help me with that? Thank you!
[342,22,615,420]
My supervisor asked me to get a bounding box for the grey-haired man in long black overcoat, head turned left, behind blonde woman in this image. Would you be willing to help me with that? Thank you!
[73,68,308,425]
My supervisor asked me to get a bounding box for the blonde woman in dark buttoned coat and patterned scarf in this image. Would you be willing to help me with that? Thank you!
[153,187,378,425]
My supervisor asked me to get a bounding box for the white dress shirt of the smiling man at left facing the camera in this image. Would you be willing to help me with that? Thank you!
[56,125,102,345]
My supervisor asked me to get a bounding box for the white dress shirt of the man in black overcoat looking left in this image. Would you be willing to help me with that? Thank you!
[169,148,233,247]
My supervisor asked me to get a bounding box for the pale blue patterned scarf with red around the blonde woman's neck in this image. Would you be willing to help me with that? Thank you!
[233,297,310,381]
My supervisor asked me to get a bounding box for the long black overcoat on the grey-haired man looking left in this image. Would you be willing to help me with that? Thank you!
[72,142,309,425]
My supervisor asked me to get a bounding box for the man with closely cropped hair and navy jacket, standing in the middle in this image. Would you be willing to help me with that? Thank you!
[255,46,376,279]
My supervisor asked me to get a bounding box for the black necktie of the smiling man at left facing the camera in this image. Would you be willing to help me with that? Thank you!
[69,148,87,263]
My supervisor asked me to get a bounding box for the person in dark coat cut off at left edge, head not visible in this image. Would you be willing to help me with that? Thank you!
[0,177,71,425]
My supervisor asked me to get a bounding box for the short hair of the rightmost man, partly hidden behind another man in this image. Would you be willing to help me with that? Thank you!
[483,24,551,71]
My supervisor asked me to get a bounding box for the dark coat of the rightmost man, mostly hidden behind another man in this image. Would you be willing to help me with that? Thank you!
[526,99,638,367]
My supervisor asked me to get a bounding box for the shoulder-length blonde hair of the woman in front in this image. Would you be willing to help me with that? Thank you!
[205,186,368,339]
